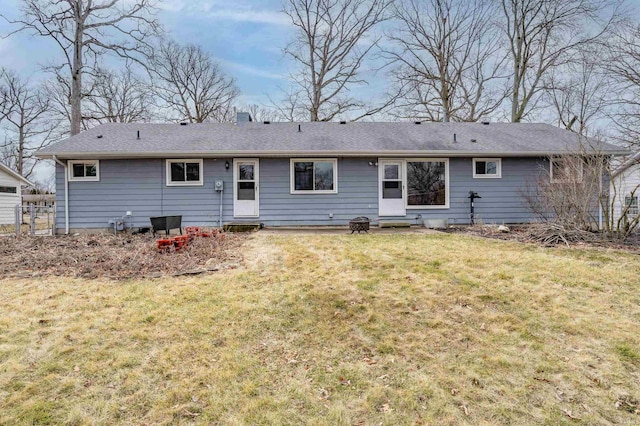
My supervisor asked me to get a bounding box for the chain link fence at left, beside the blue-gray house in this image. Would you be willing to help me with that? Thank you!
[0,203,55,237]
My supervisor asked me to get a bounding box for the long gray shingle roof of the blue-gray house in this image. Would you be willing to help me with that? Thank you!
[38,122,626,158]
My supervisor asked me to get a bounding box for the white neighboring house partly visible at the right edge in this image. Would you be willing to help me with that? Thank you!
[611,151,640,228]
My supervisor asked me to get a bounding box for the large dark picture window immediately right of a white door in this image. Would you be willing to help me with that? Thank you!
[407,161,446,206]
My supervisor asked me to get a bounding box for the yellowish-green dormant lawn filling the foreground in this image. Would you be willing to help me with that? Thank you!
[0,233,640,425]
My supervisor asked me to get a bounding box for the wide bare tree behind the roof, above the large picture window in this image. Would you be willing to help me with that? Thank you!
[386,0,506,121]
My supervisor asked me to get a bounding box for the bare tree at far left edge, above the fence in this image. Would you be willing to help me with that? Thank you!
[0,69,58,178]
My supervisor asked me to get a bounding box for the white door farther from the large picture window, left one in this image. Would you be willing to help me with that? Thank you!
[233,159,260,217]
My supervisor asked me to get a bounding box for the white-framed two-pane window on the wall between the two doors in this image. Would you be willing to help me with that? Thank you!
[291,158,338,194]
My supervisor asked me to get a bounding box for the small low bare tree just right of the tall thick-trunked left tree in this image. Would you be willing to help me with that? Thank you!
[85,67,152,123]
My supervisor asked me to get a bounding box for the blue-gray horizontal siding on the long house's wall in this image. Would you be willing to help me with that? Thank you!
[56,157,548,230]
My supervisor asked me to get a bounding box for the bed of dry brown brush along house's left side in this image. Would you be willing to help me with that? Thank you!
[0,234,246,280]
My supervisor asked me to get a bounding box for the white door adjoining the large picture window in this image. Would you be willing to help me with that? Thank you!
[378,160,407,216]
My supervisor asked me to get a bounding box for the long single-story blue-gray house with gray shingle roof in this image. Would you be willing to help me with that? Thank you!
[33,114,626,232]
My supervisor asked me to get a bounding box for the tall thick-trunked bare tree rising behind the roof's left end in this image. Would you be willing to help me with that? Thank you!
[3,0,160,135]
